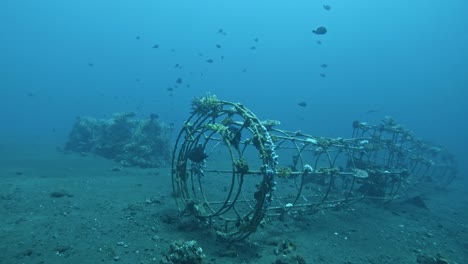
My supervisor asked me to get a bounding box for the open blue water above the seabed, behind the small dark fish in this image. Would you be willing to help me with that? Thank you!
[0,0,468,177]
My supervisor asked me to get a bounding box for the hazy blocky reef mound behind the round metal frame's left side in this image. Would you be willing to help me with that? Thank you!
[65,113,171,168]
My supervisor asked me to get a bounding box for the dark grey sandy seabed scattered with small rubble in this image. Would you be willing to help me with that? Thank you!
[0,146,468,264]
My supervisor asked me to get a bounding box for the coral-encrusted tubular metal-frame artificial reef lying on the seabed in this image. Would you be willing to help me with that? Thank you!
[172,95,457,242]
